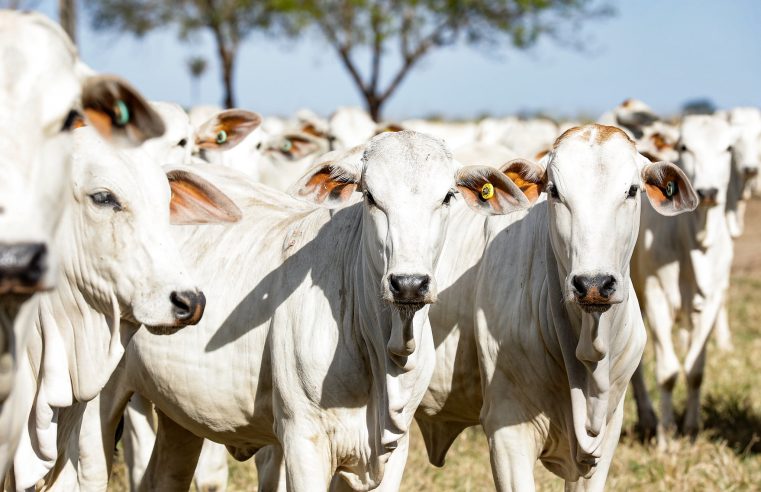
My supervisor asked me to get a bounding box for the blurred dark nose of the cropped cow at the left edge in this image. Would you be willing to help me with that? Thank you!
[0,243,48,294]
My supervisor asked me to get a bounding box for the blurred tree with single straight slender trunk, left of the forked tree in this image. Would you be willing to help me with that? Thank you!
[87,0,271,108]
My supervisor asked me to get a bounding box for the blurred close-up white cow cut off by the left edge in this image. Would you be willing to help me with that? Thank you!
[0,11,163,475]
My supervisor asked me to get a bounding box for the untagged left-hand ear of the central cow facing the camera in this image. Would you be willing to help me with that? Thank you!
[292,161,359,208]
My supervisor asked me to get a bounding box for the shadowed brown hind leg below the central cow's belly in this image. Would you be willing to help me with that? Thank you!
[140,410,203,492]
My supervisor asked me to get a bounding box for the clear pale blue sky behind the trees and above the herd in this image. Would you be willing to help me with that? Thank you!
[29,0,761,119]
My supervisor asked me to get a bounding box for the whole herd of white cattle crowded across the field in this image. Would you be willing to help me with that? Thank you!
[0,11,761,491]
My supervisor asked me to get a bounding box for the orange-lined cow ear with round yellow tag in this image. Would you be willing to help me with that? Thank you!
[455,166,531,215]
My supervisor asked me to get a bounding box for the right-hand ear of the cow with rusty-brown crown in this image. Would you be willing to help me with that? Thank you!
[642,157,698,215]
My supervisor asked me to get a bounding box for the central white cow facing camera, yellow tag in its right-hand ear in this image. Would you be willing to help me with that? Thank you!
[83,132,527,490]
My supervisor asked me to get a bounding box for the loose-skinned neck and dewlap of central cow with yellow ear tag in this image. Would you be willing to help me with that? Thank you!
[352,222,428,472]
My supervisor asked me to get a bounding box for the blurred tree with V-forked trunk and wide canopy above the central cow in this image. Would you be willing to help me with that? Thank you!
[278,0,610,121]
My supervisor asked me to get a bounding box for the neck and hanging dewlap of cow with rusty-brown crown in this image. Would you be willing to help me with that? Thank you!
[545,236,629,476]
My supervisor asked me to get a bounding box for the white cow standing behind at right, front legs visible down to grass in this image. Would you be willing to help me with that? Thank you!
[632,115,733,445]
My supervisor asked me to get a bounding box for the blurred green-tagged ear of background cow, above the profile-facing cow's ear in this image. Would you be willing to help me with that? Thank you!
[196,109,262,150]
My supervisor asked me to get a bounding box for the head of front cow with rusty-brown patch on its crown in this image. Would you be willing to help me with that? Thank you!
[545,125,696,312]
